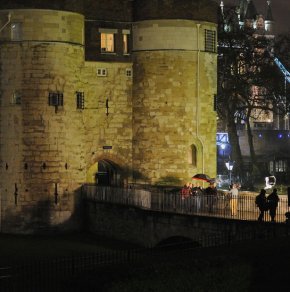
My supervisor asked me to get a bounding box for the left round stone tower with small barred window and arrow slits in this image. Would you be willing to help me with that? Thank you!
[0,9,85,232]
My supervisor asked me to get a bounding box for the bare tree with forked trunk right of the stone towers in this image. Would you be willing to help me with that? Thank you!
[217,28,282,177]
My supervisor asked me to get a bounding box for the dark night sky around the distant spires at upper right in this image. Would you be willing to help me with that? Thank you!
[216,0,290,33]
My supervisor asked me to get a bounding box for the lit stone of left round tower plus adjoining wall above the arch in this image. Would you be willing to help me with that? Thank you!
[0,10,132,232]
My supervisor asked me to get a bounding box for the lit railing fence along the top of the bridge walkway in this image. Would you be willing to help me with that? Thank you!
[82,185,289,222]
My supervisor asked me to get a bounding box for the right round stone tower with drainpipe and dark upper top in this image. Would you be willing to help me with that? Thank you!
[133,0,217,184]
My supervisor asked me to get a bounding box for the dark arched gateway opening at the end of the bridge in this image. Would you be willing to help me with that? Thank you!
[96,159,123,186]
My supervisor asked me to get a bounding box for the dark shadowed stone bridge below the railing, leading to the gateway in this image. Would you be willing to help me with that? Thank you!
[85,186,290,247]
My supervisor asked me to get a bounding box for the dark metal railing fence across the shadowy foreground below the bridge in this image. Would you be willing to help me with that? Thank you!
[0,229,289,292]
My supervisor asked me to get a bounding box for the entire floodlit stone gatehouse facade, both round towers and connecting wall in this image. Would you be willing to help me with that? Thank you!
[0,0,216,232]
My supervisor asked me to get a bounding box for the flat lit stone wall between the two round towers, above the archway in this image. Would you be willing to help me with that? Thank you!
[82,62,132,184]
